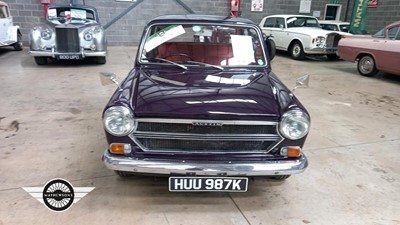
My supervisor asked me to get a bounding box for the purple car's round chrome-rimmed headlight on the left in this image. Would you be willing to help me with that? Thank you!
[103,106,135,136]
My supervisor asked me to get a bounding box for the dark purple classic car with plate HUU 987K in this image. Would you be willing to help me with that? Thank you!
[99,15,310,192]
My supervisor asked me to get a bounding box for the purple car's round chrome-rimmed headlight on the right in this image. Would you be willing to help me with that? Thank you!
[279,110,310,140]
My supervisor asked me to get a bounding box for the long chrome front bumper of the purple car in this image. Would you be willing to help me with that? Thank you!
[103,150,308,176]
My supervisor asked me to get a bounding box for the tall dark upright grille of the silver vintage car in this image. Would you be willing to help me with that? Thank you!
[56,27,80,53]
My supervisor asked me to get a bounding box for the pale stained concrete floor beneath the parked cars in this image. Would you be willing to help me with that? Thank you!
[0,47,400,225]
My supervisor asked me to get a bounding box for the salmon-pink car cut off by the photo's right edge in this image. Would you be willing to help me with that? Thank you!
[338,21,400,77]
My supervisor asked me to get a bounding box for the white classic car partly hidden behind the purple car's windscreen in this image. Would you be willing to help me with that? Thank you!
[260,15,341,59]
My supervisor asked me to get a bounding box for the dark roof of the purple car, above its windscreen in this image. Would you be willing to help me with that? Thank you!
[149,14,256,25]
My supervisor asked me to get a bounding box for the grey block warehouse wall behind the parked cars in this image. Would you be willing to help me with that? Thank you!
[3,0,400,45]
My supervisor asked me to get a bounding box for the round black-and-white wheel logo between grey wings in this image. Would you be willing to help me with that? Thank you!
[43,179,75,212]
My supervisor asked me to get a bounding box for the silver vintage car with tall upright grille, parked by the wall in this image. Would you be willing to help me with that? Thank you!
[29,4,107,65]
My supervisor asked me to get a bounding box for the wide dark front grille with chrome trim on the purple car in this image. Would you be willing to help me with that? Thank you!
[130,119,282,153]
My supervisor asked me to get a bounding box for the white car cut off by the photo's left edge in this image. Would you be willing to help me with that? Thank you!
[0,1,22,51]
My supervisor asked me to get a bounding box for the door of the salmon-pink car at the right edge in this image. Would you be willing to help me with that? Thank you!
[376,26,400,74]
